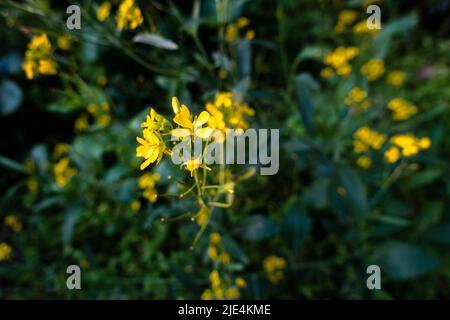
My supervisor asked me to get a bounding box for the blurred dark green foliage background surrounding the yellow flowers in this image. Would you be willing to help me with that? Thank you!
[0,0,450,299]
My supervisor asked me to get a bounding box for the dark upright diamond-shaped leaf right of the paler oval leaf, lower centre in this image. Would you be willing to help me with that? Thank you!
[281,202,311,252]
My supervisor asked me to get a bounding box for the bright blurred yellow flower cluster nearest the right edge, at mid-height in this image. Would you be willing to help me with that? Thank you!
[384,133,431,163]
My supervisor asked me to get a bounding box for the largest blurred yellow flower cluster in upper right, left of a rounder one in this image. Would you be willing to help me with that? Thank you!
[321,46,359,77]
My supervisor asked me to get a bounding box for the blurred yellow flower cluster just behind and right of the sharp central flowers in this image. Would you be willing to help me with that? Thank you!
[205,92,255,142]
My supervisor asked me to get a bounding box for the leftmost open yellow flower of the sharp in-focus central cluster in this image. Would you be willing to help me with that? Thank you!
[136,129,166,170]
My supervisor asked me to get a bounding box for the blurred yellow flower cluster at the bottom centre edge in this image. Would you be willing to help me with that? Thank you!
[200,270,247,300]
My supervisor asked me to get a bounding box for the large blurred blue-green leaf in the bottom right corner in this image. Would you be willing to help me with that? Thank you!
[380,242,438,279]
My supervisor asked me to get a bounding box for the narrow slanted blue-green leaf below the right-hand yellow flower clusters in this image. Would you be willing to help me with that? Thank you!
[338,167,368,213]
